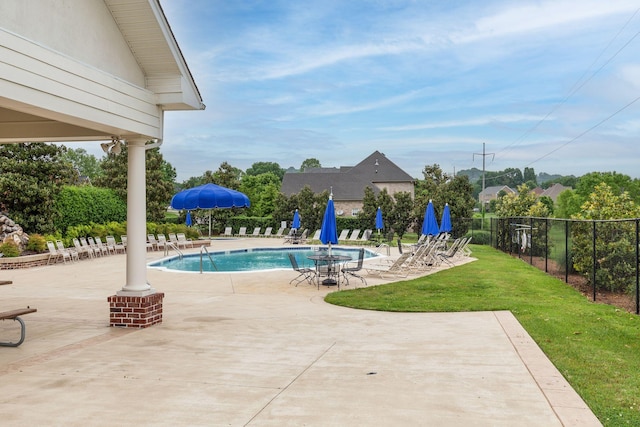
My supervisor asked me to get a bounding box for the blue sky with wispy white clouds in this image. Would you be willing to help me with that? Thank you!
[87,0,640,181]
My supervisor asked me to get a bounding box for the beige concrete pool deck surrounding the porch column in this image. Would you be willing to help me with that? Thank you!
[0,238,601,427]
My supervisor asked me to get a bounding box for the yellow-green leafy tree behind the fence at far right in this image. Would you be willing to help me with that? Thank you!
[572,183,640,291]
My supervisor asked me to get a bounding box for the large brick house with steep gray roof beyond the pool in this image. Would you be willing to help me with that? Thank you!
[281,151,414,216]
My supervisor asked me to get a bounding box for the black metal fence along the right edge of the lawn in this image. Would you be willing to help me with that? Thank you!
[480,217,640,314]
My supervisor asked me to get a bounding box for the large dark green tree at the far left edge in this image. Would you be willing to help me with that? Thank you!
[0,143,77,234]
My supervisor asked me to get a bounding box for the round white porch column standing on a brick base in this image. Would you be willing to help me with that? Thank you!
[118,139,155,296]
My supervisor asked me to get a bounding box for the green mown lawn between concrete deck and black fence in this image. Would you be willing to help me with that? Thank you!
[326,245,640,426]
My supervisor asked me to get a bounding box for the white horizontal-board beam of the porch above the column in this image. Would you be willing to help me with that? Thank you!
[0,29,162,138]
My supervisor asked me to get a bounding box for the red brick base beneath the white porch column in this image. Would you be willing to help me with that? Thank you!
[107,292,164,328]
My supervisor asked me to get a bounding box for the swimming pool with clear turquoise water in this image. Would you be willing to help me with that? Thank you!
[148,246,379,273]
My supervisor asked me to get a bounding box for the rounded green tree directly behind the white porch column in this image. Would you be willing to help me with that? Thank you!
[95,145,175,222]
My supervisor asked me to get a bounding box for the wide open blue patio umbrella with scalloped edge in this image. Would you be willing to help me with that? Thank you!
[171,184,251,236]
